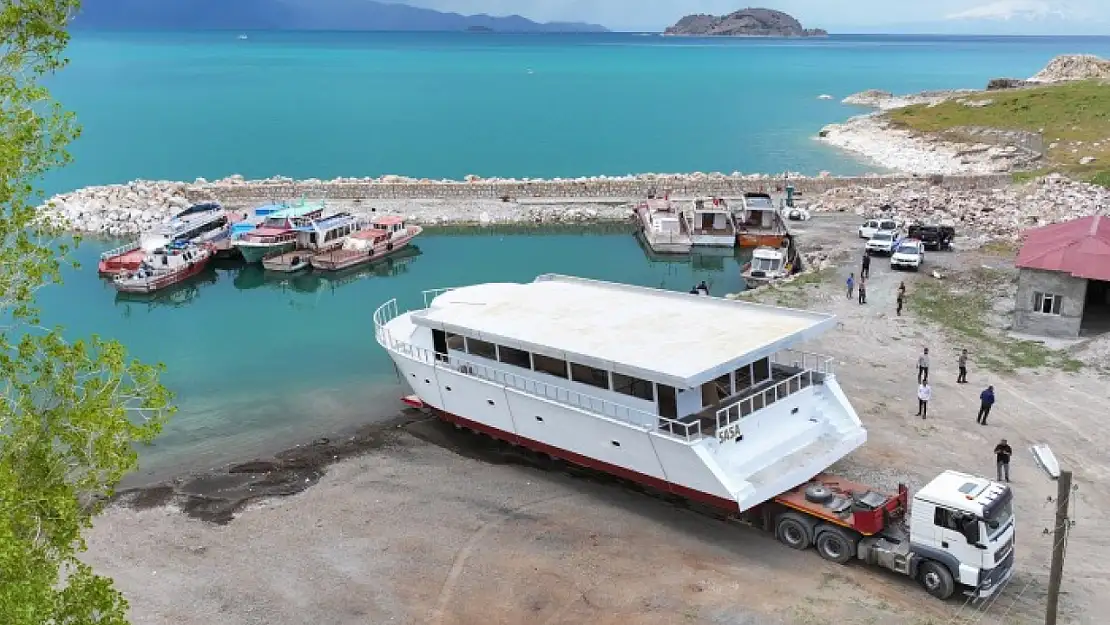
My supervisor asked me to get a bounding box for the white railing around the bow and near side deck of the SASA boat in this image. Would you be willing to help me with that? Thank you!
[374,289,703,442]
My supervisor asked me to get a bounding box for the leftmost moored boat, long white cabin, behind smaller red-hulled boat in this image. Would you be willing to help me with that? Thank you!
[97,202,231,275]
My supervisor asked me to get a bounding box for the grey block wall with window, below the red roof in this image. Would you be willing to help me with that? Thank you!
[1013,269,1087,337]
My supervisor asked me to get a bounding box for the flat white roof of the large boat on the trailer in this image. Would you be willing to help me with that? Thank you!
[412,274,836,389]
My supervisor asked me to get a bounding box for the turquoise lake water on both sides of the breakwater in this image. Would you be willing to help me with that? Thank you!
[30,32,1110,476]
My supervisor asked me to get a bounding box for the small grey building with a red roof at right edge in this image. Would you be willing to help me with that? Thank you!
[1013,215,1110,337]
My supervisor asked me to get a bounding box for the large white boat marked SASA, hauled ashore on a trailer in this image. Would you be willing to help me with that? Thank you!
[374,275,867,512]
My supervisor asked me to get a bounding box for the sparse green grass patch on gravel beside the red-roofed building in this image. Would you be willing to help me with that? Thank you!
[909,269,1083,373]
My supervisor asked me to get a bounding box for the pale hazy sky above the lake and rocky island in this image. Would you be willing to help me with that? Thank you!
[393,0,1110,34]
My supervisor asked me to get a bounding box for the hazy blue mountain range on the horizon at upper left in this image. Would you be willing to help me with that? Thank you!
[72,0,608,32]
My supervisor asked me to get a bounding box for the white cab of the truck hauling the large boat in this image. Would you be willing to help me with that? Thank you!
[909,471,1015,598]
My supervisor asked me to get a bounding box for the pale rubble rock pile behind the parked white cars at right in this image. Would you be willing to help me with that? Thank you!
[809,174,1110,248]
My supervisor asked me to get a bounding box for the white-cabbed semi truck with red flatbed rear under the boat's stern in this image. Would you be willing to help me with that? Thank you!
[746,471,1016,599]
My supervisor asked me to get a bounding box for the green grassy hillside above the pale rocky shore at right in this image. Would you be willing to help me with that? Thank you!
[888,81,1110,187]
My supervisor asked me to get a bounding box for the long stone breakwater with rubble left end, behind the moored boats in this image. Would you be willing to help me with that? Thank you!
[41,174,1010,236]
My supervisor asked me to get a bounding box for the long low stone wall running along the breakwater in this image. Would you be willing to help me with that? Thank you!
[186,173,1011,204]
